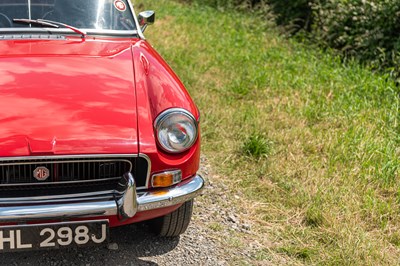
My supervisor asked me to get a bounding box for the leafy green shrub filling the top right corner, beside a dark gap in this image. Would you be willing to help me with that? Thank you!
[310,0,400,77]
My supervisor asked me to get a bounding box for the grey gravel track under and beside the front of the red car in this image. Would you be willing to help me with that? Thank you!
[0,158,249,266]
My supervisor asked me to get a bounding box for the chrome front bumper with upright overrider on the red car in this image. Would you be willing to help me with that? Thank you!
[0,174,204,222]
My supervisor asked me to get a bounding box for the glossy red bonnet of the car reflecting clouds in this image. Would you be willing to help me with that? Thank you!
[0,38,138,156]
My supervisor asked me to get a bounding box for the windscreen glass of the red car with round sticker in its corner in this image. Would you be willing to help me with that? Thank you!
[0,0,136,31]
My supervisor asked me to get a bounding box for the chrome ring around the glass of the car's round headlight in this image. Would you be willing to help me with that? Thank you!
[153,108,199,154]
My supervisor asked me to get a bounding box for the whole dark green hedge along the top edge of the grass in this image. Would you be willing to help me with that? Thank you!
[181,0,400,83]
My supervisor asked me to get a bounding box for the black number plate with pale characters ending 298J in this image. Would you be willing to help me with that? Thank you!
[0,220,109,253]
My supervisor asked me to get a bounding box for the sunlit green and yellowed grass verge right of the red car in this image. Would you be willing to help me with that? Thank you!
[136,0,400,265]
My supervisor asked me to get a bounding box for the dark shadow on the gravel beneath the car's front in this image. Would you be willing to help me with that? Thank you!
[0,223,179,266]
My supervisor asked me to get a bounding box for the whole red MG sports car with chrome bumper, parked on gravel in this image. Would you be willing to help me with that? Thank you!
[0,0,204,252]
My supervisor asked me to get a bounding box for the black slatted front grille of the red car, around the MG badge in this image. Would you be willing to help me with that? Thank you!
[0,157,149,200]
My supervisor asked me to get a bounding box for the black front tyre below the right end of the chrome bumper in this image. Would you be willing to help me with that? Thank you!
[149,200,193,237]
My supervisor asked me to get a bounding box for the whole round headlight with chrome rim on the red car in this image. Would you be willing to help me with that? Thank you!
[154,108,198,153]
